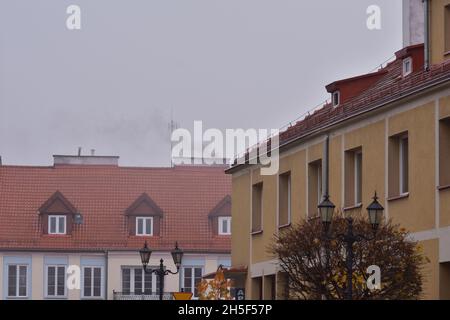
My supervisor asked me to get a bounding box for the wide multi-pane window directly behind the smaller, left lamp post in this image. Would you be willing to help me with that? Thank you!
[122,267,160,295]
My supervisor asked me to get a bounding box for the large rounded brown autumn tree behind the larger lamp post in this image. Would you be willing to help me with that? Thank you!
[270,216,429,300]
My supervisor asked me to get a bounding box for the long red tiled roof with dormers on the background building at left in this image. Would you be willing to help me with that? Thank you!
[0,165,231,252]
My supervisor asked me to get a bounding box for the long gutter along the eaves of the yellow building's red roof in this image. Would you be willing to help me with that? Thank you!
[225,74,450,174]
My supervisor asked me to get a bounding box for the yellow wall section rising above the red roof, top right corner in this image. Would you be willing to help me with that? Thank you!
[430,0,450,64]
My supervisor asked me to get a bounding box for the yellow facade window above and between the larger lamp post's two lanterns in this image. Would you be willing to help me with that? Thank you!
[345,148,362,207]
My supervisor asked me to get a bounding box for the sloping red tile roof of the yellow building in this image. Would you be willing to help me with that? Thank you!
[227,45,450,173]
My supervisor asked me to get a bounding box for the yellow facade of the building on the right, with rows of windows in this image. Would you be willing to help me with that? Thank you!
[228,0,450,299]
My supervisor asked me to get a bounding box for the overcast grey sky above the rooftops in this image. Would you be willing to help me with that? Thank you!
[0,0,402,166]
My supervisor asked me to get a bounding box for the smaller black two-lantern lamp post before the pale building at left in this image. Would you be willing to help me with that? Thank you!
[139,241,183,300]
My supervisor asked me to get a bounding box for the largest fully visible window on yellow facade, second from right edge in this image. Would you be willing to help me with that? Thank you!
[388,133,409,198]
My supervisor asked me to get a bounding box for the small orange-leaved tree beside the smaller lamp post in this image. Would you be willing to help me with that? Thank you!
[197,267,232,300]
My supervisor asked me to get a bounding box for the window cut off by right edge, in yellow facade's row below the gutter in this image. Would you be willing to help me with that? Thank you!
[439,118,450,186]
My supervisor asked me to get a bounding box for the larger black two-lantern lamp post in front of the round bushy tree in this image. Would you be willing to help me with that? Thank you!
[318,192,384,300]
